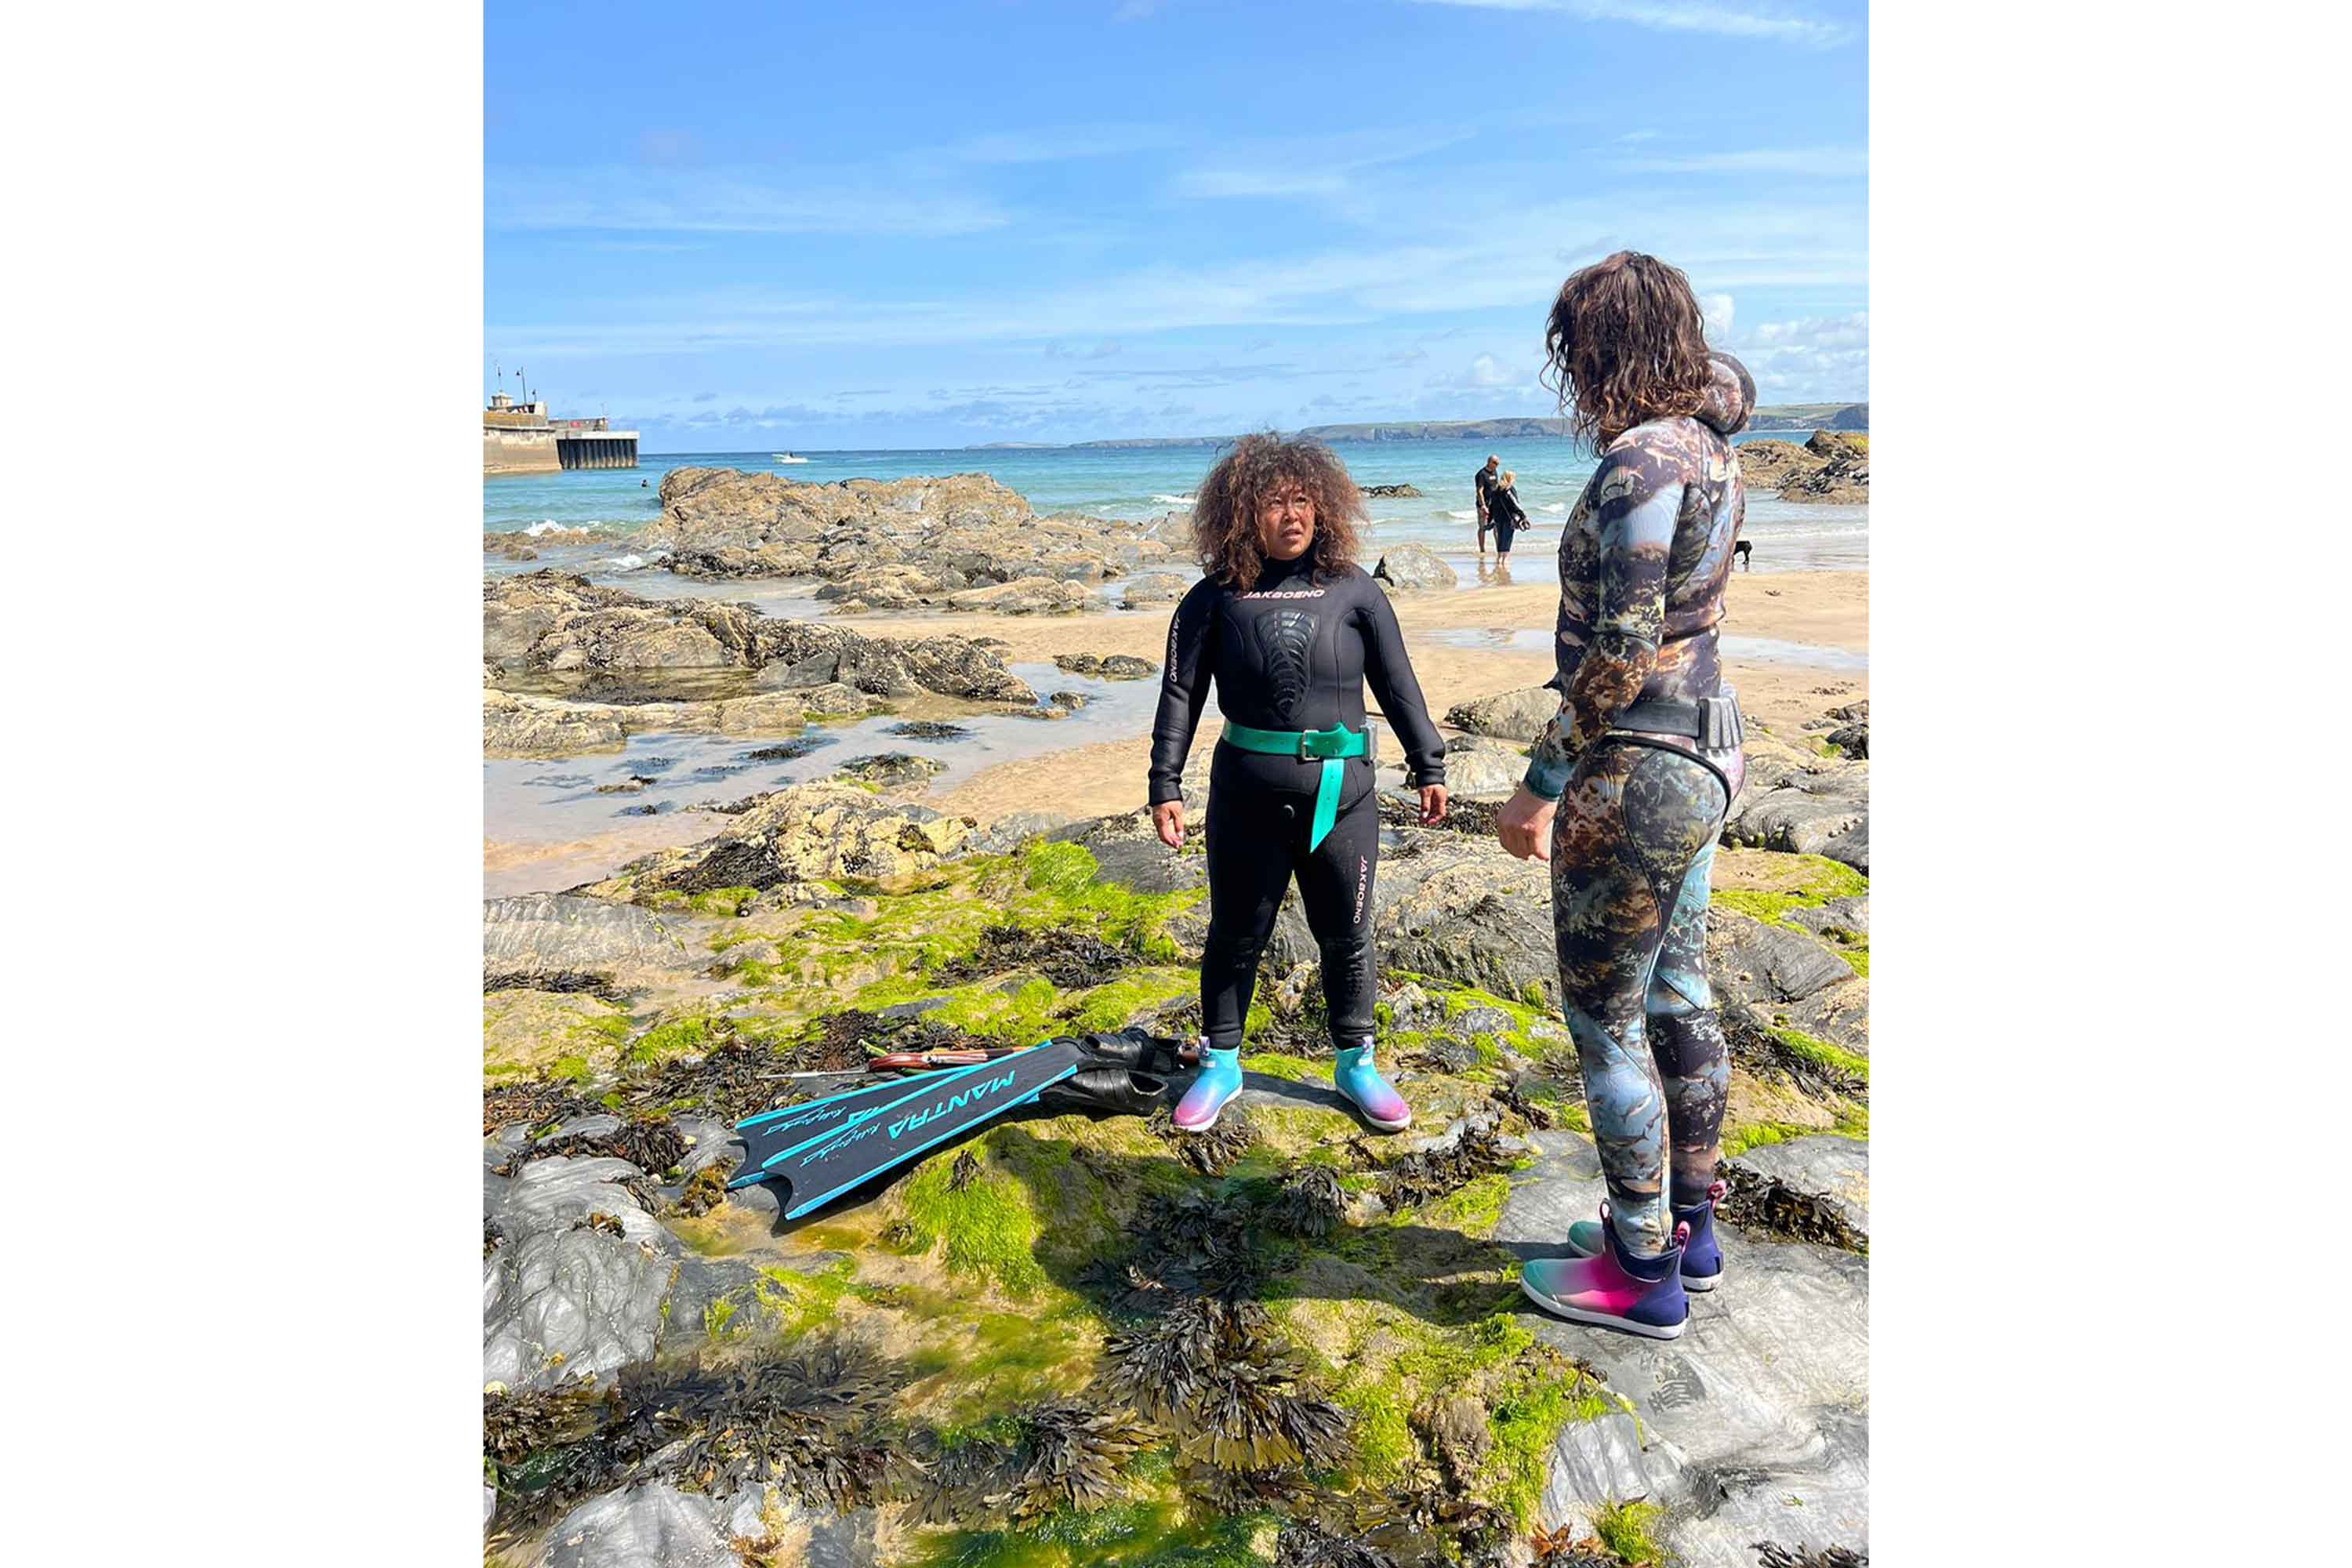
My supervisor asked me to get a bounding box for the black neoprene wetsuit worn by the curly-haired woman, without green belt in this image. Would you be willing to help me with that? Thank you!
[1150,560,1446,1051]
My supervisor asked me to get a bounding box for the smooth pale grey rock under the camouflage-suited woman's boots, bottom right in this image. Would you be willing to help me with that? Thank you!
[1496,1133,1870,1568]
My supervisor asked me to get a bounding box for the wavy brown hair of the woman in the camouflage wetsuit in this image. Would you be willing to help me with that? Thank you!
[1543,252,1710,447]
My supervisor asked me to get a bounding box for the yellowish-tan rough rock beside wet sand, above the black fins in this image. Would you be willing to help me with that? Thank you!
[581,783,971,898]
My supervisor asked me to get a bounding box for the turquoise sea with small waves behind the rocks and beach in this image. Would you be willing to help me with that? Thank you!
[482,430,1870,593]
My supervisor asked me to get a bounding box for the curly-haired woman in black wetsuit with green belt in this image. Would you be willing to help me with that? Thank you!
[1150,435,1446,1133]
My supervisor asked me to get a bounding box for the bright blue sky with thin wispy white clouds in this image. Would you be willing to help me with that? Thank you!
[482,0,1870,452]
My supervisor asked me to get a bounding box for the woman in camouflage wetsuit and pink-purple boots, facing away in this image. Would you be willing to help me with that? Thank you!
[1496,252,1755,1338]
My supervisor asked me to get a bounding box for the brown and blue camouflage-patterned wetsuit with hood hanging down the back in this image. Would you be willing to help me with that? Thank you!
[1526,355,1755,1258]
